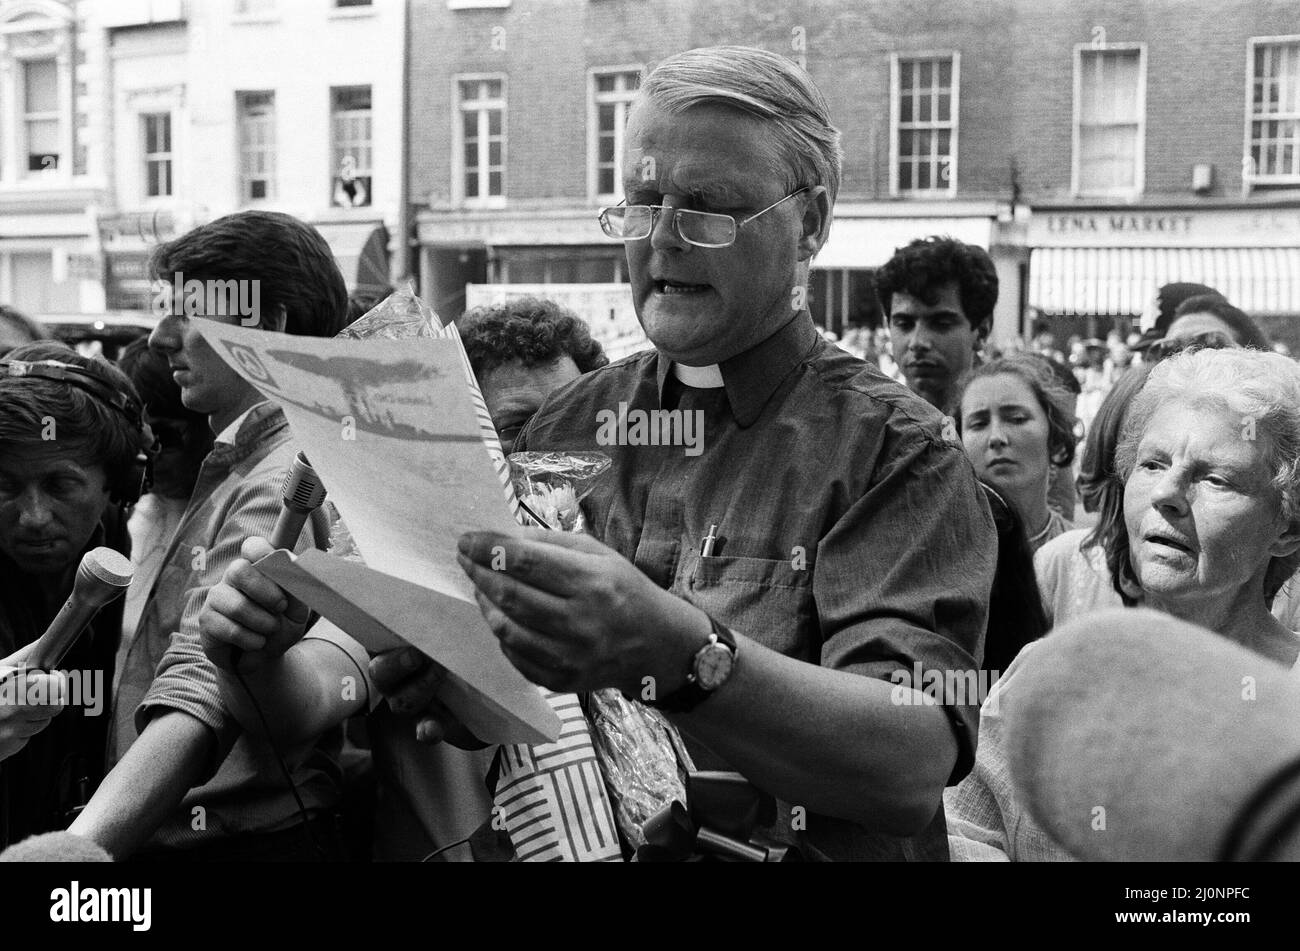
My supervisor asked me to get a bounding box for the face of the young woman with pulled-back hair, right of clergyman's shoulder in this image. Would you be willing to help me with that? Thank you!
[961,373,1052,495]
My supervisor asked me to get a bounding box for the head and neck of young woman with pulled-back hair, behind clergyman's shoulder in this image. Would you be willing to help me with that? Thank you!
[957,353,1074,551]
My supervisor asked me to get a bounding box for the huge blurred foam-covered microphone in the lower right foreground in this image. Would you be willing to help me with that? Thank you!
[1001,609,1300,861]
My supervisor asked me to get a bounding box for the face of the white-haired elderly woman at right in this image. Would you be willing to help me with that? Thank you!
[1125,400,1297,602]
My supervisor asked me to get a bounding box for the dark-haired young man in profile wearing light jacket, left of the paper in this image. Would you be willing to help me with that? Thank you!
[72,212,369,860]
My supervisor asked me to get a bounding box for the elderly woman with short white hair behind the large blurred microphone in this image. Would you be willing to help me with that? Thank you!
[944,349,1300,861]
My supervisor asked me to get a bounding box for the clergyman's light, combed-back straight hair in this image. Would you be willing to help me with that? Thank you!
[641,47,844,204]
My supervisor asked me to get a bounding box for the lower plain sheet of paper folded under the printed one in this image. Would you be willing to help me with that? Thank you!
[256,548,560,743]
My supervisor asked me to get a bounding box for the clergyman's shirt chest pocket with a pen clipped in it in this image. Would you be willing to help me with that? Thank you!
[673,551,819,660]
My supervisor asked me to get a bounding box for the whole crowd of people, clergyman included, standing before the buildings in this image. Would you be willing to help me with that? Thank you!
[0,47,1300,863]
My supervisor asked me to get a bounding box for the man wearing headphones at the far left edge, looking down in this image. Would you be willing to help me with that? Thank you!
[0,343,153,847]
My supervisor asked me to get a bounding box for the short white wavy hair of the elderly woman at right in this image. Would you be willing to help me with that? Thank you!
[1115,348,1300,521]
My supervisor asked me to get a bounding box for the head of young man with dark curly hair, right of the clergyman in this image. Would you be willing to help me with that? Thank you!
[876,236,997,413]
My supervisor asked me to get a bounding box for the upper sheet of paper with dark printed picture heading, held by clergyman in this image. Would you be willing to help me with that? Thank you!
[194,318,519,602]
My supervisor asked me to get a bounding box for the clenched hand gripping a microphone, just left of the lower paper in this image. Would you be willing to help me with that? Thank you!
[199,538,308,670]
